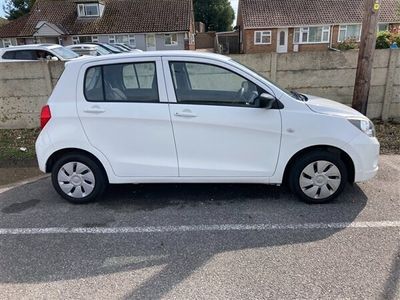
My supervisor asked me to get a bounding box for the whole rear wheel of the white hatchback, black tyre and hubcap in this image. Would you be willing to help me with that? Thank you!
[51,153,108,204]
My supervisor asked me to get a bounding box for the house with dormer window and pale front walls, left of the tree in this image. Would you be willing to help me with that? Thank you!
[0,0,195,50]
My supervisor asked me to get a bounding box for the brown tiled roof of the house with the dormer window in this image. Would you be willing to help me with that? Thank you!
[0,0,192,37]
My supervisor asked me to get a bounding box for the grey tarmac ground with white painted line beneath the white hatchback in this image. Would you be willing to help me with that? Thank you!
[0,156,400,299]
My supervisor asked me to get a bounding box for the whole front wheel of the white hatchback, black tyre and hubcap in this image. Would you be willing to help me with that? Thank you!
[289,151,347,204]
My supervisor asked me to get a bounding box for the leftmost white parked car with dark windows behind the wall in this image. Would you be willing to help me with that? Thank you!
[0,44,79,62]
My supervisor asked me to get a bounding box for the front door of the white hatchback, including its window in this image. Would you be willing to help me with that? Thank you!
[163,58,281,177]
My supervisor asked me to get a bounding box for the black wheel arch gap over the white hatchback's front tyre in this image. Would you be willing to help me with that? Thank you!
[283,145,355,183]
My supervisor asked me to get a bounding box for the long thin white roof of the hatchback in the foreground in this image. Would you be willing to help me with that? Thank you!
[67,50,231,65]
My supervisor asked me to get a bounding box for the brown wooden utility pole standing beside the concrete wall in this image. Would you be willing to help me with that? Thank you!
[352,0,381,115]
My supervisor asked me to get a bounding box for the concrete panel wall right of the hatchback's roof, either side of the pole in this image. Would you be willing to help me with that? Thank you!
[231,49,400,120]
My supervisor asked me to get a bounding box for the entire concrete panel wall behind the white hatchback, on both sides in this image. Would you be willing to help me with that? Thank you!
[0,50,400,128]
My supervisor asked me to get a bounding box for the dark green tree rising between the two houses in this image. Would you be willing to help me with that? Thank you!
[194,0,235,31]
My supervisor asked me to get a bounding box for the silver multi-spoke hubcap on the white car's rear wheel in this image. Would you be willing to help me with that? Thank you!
[57,162,95,198]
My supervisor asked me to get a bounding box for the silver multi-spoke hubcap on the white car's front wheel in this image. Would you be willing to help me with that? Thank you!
[299,160,342,199]
